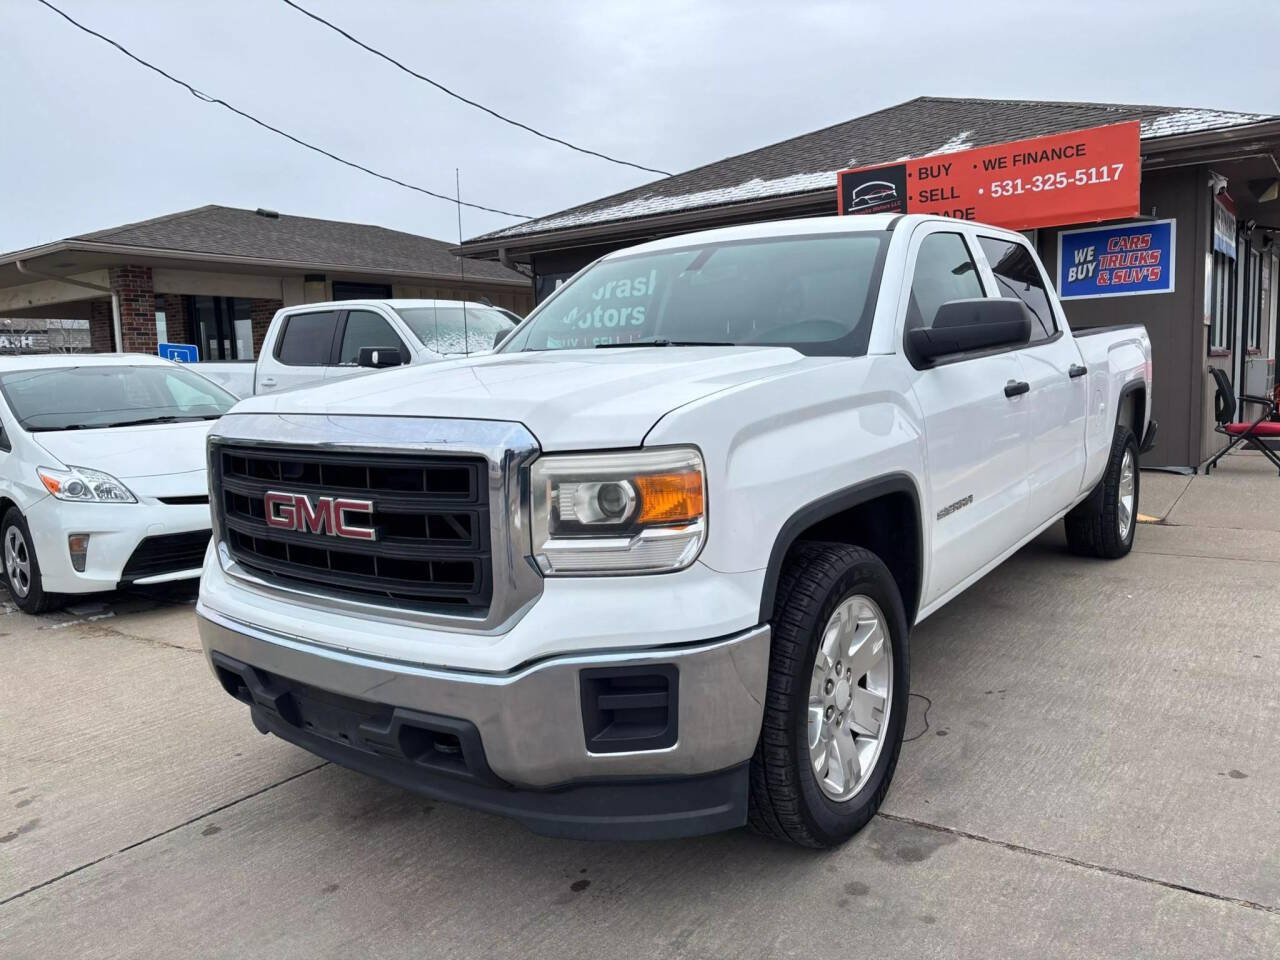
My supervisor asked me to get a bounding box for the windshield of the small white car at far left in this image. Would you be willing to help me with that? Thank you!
[0,364,236,433]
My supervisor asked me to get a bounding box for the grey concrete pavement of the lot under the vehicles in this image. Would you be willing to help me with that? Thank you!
[0,454,1280,960]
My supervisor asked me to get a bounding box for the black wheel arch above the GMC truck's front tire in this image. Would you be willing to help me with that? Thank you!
[760,472,924,625]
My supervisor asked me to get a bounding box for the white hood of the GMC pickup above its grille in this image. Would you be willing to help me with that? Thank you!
[232,347,829,449]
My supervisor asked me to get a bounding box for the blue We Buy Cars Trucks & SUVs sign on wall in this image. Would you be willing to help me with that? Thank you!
[1057,220,1175,300]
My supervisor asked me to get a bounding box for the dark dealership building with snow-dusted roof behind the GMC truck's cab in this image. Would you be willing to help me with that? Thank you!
[461,97,1280,467]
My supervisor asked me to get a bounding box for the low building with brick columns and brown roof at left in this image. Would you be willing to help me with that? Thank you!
[0,205,534,361]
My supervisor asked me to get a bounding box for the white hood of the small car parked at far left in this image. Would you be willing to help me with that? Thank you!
[31,420,216,481]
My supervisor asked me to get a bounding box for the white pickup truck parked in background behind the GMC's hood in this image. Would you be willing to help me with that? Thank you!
[192,300,520,397]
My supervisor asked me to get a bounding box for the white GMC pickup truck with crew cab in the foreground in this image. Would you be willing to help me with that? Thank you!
[197,215,1155,846]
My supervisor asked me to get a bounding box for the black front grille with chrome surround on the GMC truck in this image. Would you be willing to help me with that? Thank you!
[209,413,541,631]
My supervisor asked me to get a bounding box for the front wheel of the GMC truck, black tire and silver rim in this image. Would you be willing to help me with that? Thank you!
[749,543,910,847]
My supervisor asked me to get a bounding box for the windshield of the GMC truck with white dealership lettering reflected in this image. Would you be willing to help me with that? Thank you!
[499,230,890,356]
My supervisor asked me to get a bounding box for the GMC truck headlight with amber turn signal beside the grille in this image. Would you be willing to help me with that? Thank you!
[530,447,707,575]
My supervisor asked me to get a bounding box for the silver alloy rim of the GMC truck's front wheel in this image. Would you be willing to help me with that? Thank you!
[809,595,893,803]
